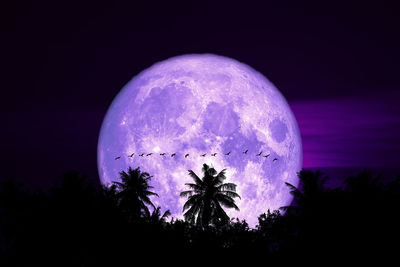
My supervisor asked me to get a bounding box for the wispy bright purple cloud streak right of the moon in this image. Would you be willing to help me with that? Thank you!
[290,92,400,168]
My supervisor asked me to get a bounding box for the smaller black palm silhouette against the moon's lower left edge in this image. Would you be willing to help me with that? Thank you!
[114,167,158,220]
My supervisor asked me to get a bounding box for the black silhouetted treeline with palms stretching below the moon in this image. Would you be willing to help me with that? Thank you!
[0,168,400,266]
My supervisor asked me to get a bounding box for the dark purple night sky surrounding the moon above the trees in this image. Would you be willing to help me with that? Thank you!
[0,1,400,186]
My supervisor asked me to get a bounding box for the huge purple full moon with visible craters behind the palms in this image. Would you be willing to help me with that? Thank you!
[98,54,302,227]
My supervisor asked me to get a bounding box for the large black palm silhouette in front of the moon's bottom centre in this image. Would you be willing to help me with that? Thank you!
[180,164,240,227]
